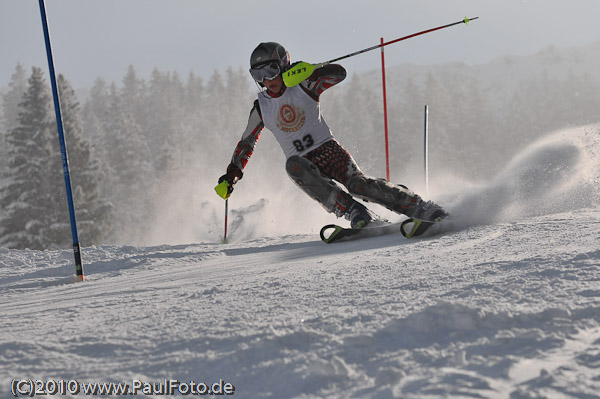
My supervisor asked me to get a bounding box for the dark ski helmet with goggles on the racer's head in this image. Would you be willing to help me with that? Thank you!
[250,42,290,84]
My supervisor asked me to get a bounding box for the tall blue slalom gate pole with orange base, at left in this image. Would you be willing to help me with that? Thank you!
[39,0,84,281]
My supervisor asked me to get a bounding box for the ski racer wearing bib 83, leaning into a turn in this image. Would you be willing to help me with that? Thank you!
[219,42,447,229]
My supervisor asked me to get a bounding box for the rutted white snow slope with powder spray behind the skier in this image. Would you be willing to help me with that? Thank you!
[0,126,600,399]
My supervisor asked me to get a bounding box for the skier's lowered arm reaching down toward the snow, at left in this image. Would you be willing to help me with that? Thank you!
[219,100,265,184]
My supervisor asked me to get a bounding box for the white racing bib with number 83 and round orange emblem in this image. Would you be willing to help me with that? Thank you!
[258,86,333,159]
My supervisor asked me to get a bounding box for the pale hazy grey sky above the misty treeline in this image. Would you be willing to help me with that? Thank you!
[0,0,600,88]
